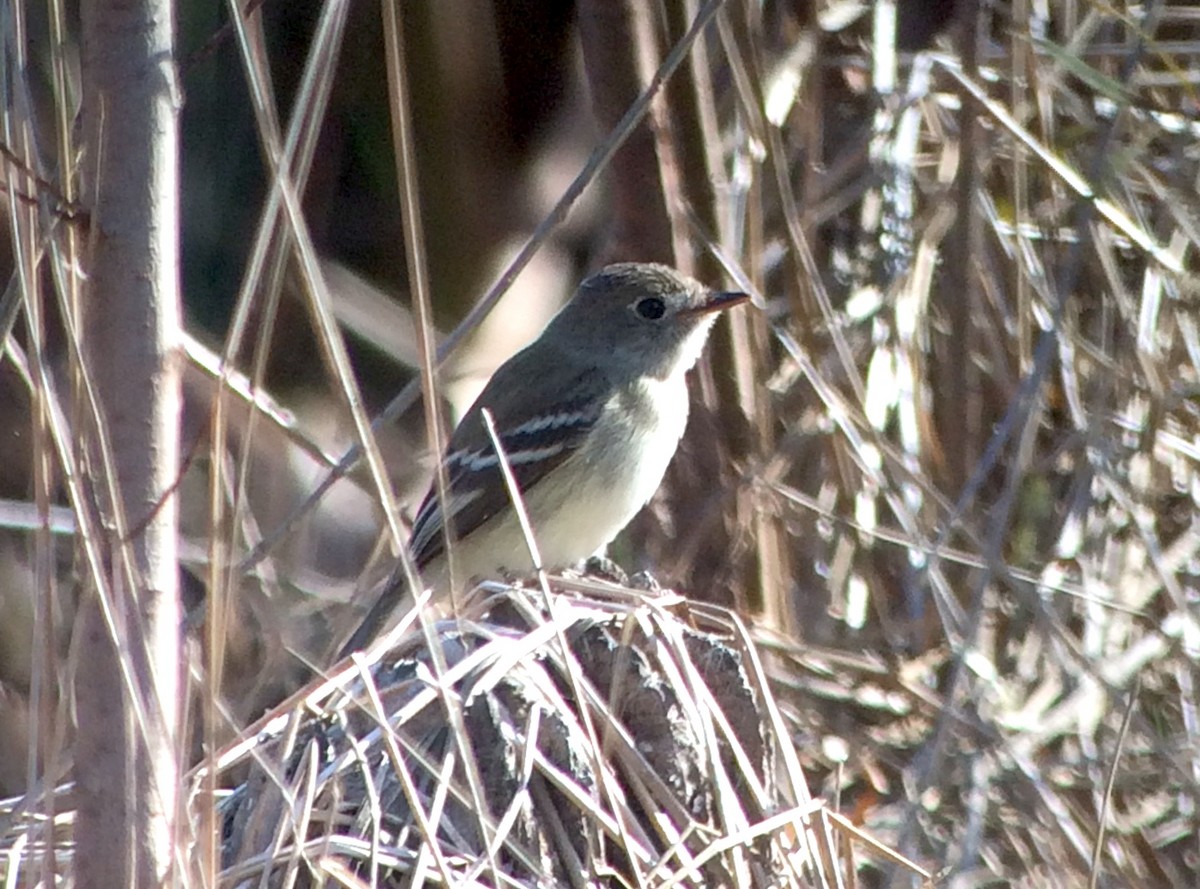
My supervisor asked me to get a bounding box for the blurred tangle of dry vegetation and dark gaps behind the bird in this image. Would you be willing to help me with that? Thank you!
[0,0,1200,887]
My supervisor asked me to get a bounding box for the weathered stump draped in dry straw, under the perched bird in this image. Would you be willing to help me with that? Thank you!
[208,581,917,887]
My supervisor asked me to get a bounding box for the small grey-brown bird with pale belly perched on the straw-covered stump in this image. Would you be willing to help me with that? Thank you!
[342,263,749,655]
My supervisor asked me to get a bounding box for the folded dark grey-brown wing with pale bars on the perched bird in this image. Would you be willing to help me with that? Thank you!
[409,349,606,567]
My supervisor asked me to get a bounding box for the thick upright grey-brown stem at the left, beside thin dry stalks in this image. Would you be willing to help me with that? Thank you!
[76,0,181,889]
